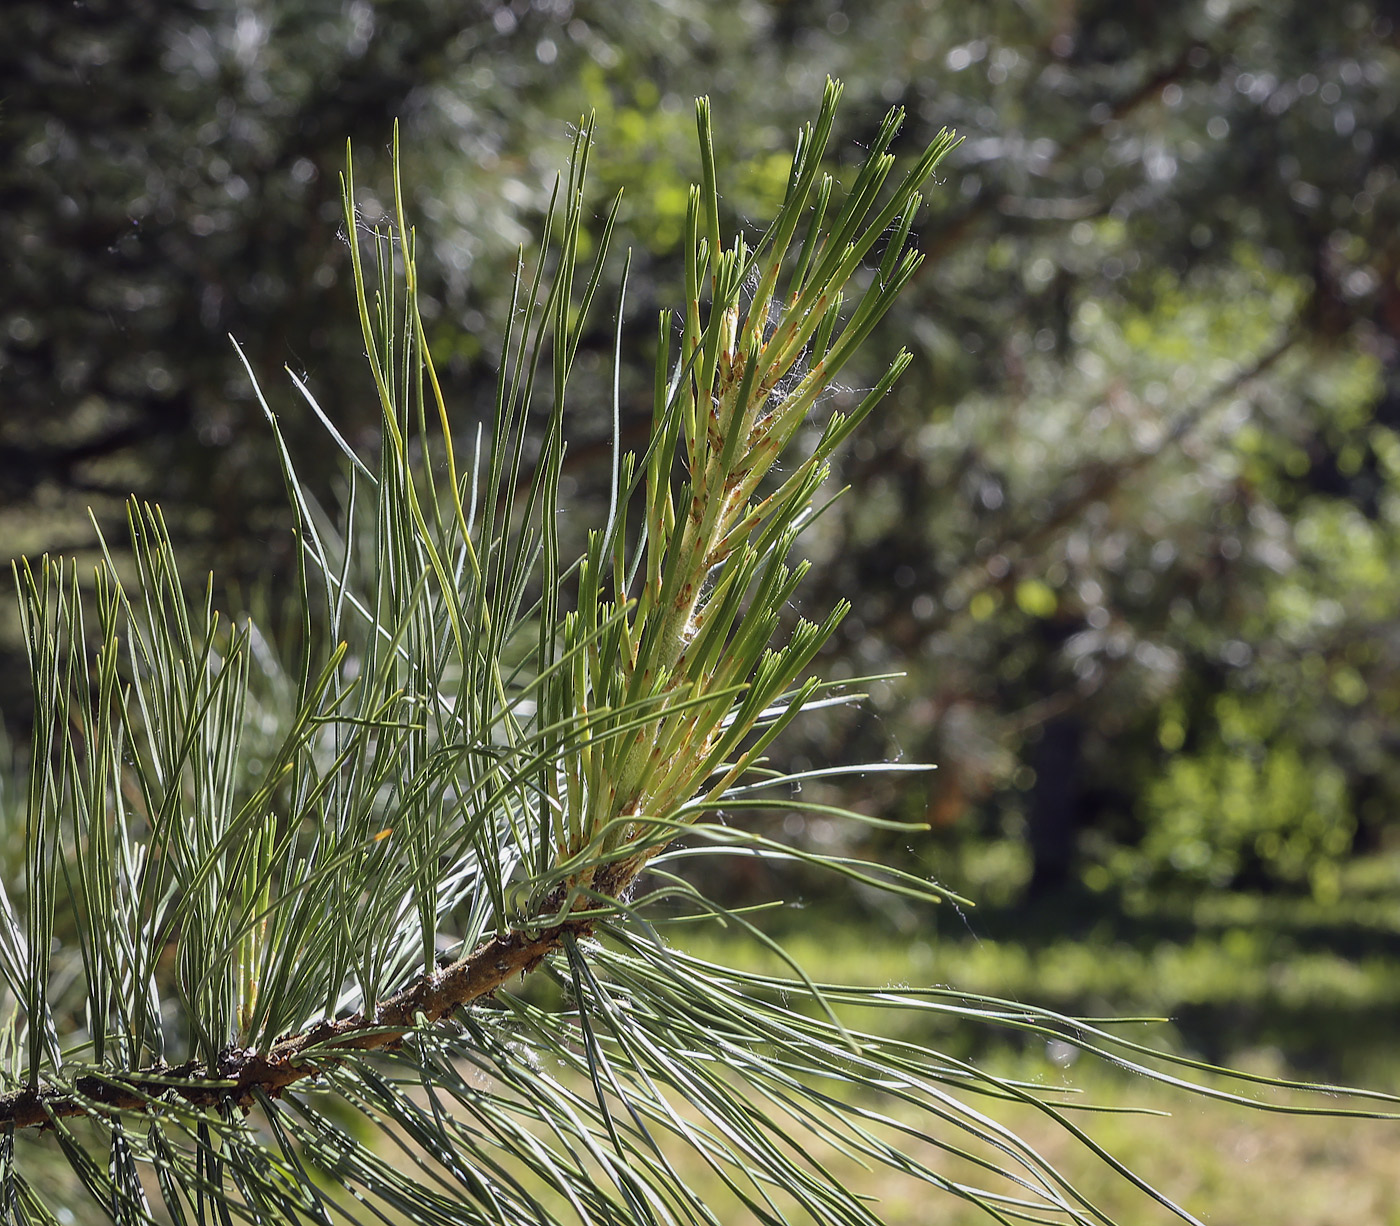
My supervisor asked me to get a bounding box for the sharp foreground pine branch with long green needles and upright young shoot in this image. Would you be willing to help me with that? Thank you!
[0,85,1396,1223]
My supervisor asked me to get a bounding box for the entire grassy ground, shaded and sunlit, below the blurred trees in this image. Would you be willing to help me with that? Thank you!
[658,851,1400,1226]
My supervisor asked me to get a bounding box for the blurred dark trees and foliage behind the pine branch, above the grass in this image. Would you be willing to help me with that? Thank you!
[0,0,1400,1074]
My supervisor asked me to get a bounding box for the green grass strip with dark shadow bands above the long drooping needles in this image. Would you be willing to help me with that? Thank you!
[673,844,1400,1086]
